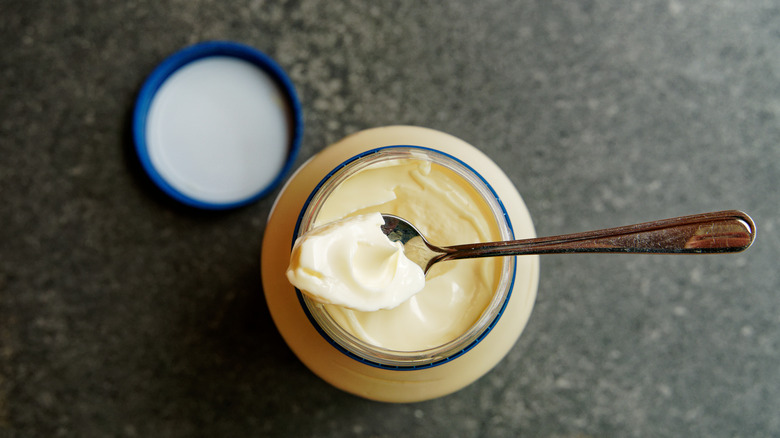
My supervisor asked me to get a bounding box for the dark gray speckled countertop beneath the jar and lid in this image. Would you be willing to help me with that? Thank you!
[0,0,780,437]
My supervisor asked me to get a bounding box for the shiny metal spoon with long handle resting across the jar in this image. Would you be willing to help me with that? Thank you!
[381,210,756,273]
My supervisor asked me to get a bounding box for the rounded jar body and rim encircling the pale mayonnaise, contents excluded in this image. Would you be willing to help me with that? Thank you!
[262,126,538,402]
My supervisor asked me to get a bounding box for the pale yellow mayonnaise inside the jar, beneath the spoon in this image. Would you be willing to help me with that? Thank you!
[286,159,503,351]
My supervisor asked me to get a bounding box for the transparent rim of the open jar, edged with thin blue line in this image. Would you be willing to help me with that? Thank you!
[293,146,515,370]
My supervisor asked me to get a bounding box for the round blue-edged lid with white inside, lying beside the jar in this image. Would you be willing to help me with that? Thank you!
[133,41,303,209]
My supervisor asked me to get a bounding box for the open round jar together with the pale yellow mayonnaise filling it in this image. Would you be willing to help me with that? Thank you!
[262,126,539,402]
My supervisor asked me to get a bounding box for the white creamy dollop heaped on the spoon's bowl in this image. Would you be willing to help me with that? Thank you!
[287,213,425,312]
